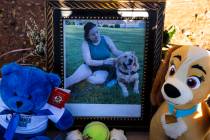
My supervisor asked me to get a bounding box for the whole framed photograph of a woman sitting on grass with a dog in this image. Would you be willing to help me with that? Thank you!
[46,0,165,130]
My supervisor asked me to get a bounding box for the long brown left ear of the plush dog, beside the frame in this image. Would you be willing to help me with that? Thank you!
[150,44,181,106]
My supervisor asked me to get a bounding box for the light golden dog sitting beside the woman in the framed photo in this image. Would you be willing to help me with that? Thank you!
[115,52,139,97]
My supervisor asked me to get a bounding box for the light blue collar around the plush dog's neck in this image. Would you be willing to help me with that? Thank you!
[168,103,198,118]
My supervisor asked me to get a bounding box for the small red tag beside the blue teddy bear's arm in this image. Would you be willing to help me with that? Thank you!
[48,88,70,108]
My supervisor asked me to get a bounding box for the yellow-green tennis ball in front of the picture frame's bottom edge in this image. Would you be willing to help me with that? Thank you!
[83,121,110,140]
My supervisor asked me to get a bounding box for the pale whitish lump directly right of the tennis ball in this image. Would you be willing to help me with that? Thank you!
[110,129,127,140]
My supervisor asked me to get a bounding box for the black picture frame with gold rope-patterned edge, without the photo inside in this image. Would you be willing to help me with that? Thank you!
[46,0,165,130]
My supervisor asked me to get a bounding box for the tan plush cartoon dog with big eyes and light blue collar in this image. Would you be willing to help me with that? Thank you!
[149,46,210,140]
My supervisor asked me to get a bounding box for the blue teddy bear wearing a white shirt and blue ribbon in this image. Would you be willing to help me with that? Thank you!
[0,63,73,140]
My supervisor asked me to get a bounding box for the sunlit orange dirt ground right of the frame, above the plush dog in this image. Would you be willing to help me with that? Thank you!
[165,0,210,49]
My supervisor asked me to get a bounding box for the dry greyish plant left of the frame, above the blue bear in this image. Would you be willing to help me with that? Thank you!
[0,17,46,65]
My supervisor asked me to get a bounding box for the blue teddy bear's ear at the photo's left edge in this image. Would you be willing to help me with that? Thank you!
[1,62,21,76]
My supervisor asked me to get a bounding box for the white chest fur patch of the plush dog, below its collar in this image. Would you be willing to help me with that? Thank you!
[161,114,187,139]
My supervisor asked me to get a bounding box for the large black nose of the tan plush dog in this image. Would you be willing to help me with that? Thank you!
[164,84,181,98]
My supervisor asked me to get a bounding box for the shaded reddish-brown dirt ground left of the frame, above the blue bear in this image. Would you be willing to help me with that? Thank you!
[0,0,45,66]
